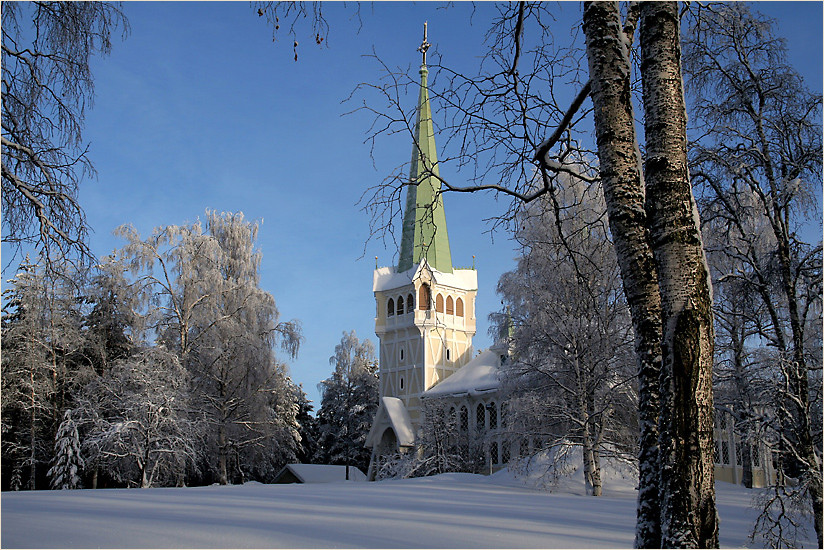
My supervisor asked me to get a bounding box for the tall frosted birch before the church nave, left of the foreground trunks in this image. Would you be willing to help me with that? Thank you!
[497,174,637,496]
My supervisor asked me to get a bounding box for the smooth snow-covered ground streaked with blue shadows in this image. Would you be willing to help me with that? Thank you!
[0,471,814,548]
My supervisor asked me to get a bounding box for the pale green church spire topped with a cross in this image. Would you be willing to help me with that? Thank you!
[398,24,452,273]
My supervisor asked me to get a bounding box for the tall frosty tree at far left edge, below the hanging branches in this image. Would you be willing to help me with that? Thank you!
[2,258,89,489]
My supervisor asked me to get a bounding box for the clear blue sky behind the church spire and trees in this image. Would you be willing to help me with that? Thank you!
[3,2,822,409]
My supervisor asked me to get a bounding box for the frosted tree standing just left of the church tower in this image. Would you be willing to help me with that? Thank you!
[314,331,378,473]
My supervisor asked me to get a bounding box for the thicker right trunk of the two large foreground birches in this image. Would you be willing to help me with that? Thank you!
[639,2,718,548]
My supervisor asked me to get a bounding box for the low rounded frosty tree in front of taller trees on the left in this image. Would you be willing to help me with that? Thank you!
[75,347,200,487]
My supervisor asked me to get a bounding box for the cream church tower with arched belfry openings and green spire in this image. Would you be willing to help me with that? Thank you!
[367,26,478,476]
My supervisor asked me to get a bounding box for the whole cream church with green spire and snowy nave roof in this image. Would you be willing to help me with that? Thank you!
[366,31,508,479]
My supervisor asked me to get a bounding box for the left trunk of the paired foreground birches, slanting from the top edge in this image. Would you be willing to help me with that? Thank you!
[584,2,661,548]
